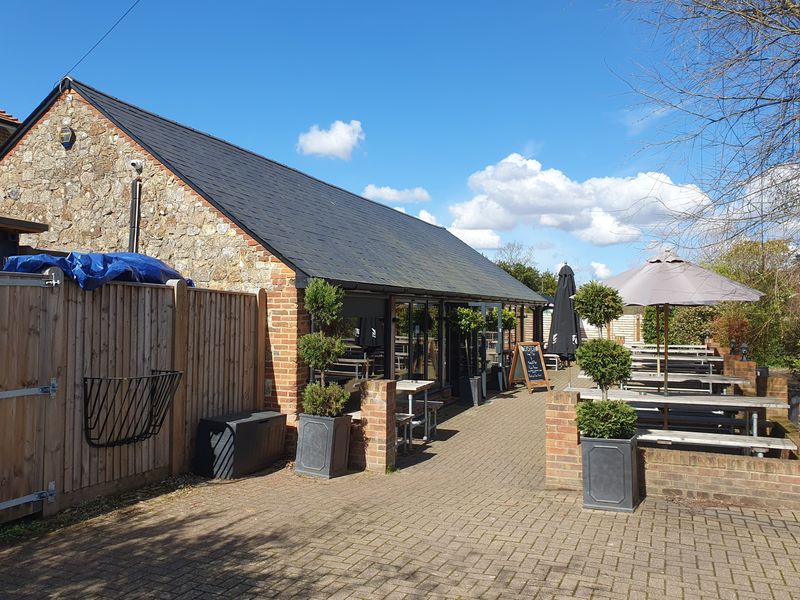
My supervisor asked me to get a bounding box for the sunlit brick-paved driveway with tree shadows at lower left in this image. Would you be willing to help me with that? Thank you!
[0,372,800,600]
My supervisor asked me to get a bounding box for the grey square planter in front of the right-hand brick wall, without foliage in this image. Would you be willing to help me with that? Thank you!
[581,436,639,512]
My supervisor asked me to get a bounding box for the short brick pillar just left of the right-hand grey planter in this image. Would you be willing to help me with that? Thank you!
[544,392,583,490]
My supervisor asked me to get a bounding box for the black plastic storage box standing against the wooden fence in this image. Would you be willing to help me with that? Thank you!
[192,411,286,479]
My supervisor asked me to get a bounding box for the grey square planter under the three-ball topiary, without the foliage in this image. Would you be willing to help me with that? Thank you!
[294,413,350,479]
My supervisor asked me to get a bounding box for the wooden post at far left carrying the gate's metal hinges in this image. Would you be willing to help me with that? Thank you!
[41,268,68,516]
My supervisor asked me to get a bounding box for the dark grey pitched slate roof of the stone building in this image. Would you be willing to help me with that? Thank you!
[3,79,544,303]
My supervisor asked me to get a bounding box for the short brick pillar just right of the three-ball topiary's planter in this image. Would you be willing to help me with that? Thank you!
[361,379,397,473]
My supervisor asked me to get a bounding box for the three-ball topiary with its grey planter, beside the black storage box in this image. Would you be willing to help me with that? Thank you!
[294,279,350,478]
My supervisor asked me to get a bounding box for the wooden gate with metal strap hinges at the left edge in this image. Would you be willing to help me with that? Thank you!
[0,274,63,522]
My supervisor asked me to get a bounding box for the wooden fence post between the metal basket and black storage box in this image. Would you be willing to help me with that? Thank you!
[167,279,189,475]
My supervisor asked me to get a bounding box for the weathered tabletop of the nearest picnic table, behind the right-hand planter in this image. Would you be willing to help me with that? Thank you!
[565,386,789,436]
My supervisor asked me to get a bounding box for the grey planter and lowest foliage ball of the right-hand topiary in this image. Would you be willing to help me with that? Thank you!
[576,398,639,512]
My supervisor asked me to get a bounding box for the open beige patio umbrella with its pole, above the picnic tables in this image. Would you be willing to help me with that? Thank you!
[605,250,764,394]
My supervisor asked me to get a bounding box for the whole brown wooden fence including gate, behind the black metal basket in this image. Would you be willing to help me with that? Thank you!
[0,273,266,522]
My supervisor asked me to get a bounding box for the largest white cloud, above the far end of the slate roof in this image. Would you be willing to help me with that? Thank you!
[449,154,708,246]
